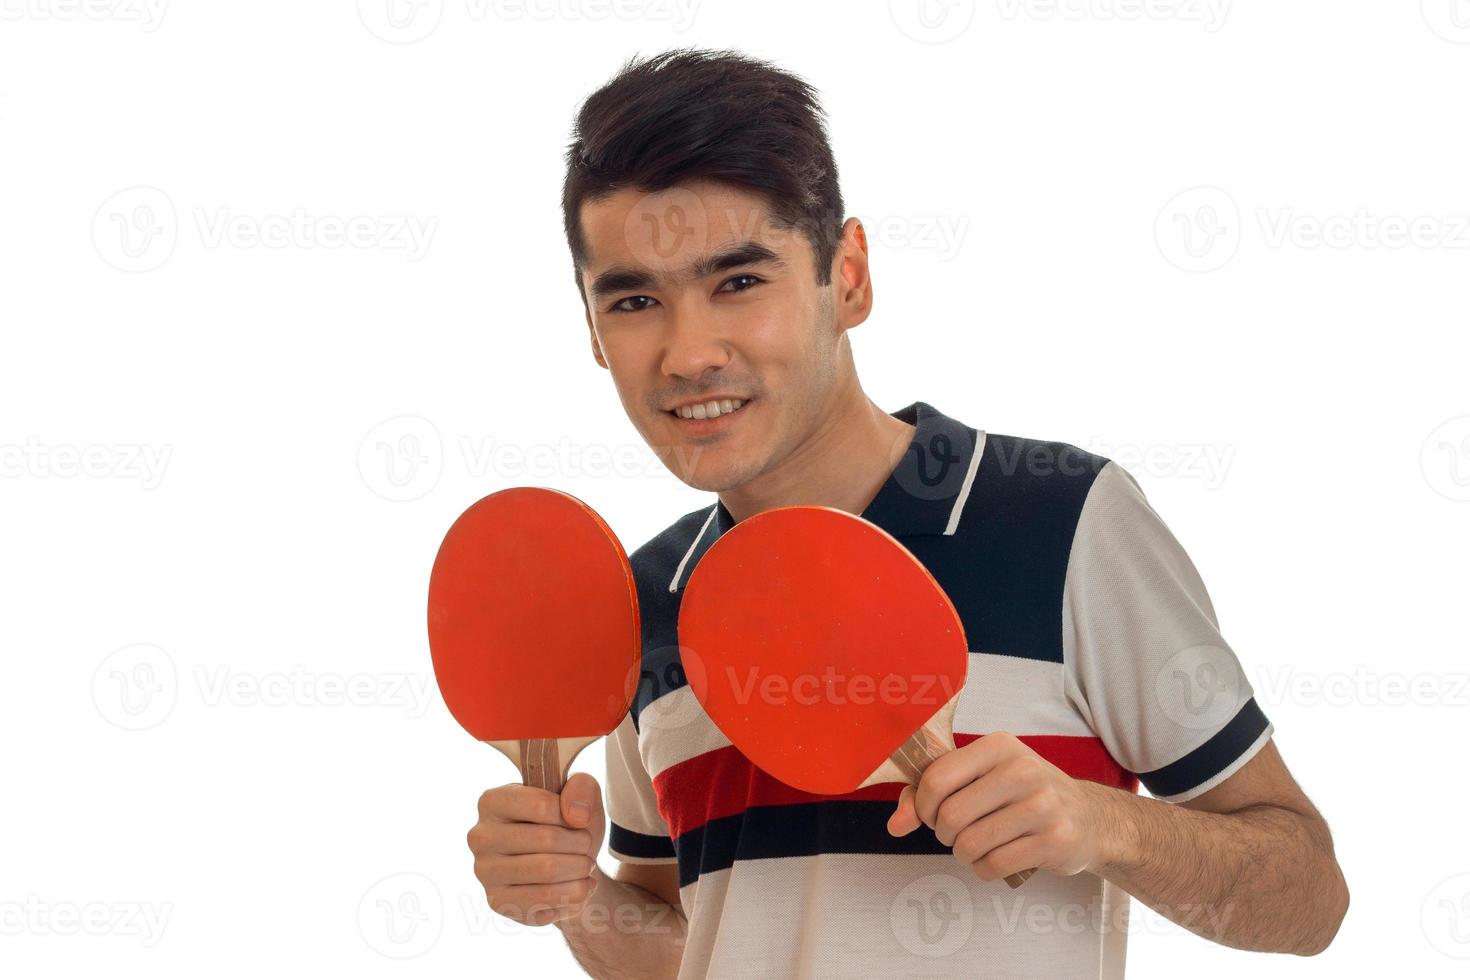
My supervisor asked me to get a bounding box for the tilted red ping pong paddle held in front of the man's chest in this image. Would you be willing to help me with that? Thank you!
[679,505,1033,887]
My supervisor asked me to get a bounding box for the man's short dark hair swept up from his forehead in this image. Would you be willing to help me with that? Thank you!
[562,48,844,299]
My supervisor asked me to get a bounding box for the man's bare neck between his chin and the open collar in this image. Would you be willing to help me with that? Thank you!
[719,383,914,522]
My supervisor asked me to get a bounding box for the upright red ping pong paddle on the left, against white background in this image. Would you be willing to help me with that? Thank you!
[429,486,642,793]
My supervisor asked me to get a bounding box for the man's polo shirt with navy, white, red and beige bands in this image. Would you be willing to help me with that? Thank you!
[606,401,1272,979]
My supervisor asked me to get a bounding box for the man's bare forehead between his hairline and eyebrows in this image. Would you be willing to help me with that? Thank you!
[581,181,794,278]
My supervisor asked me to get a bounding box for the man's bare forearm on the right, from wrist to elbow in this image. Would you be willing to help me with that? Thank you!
[1088,783,1348,955]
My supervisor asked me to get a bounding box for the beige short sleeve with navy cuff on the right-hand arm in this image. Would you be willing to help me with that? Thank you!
[1061,461,1273,802]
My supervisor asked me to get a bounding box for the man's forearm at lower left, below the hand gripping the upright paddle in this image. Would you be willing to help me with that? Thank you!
[557,867,686,980]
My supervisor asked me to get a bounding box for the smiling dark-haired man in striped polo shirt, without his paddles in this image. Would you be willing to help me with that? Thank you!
[469,51,1348,977]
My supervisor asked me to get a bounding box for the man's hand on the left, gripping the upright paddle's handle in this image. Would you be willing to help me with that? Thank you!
[467,773,606,926]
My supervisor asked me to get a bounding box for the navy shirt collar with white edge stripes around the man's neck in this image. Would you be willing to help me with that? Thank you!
[669,401,985,592]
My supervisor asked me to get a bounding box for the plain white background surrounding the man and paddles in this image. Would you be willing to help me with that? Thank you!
[0,0,1470,977]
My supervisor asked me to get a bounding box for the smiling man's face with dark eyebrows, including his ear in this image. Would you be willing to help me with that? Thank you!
[581,181,870,491]
